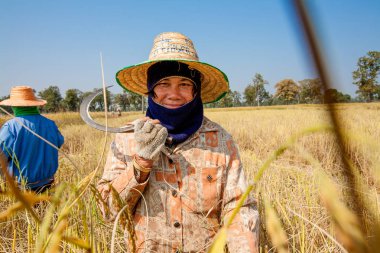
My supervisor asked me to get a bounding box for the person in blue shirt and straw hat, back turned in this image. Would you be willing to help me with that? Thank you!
[0,86,64,193]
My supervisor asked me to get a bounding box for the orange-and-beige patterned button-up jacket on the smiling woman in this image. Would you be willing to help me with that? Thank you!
[98,118,259,253]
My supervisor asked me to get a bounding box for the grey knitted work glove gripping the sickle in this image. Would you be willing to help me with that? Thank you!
[134,119,168,160]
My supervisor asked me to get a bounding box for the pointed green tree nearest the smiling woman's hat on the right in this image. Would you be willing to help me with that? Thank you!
[244,73,269,106]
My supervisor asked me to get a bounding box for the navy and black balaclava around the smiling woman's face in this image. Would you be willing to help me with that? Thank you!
[146,61,203,144]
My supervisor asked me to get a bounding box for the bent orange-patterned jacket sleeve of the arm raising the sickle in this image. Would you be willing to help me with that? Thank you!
[97,134,149,221]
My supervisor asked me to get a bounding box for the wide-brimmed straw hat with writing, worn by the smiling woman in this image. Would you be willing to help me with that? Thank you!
[116,32,228,103]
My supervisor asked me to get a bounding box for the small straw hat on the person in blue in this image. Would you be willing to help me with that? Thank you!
[0,86,46,106]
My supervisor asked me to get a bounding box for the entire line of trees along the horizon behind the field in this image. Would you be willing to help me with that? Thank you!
[0,51,380,112]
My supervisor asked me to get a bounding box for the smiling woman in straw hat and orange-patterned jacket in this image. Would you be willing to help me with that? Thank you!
[98,32,259,252]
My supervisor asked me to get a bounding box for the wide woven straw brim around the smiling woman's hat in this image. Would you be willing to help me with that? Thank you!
[116,59,229,104]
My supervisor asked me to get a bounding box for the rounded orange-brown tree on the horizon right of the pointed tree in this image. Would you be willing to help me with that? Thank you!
[275,79,299,104]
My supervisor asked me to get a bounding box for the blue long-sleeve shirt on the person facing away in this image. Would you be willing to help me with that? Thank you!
[0,114,64,188]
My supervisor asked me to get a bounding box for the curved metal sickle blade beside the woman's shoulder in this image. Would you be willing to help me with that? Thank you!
[80,86,134,133]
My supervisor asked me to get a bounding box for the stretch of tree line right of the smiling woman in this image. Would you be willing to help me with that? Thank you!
[212,51,380,107]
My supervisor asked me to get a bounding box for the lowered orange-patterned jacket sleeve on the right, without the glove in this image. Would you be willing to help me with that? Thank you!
[222,139,259,253]
